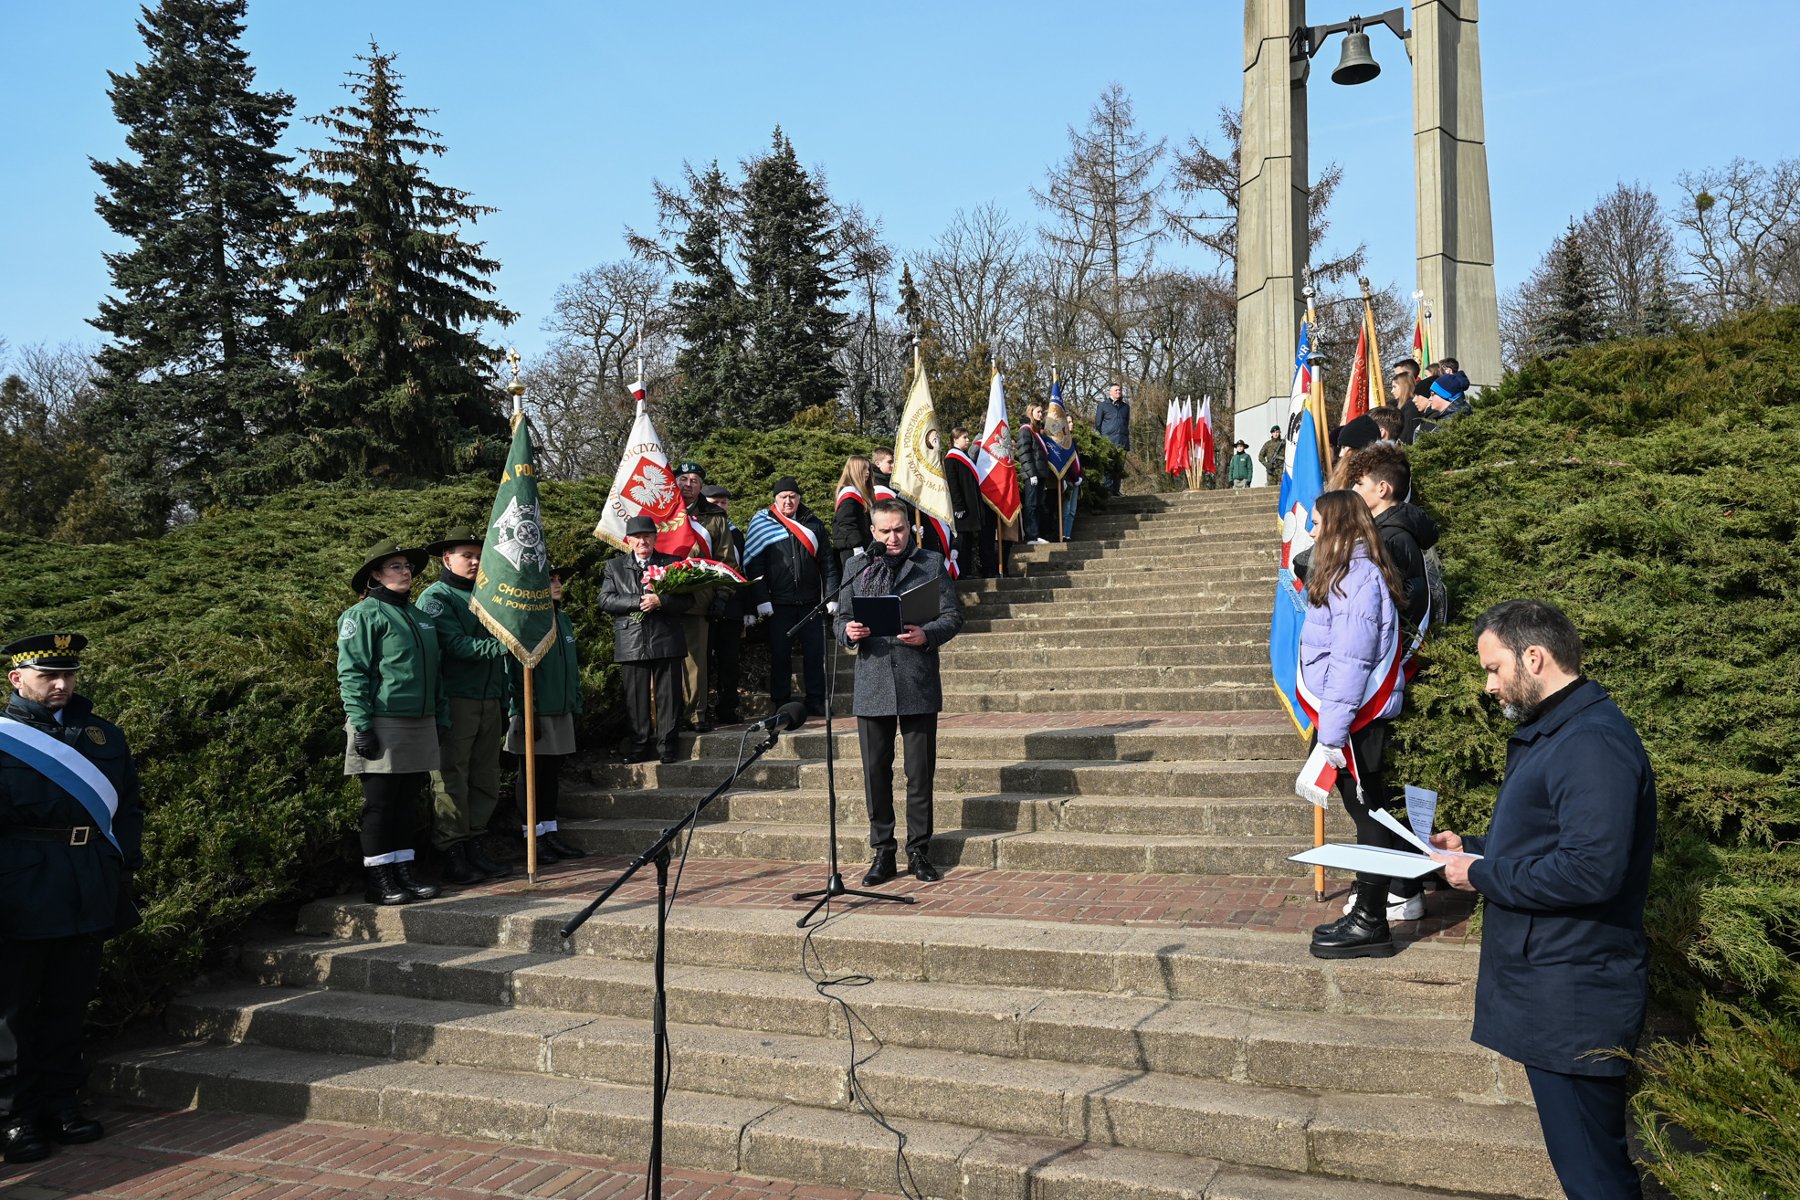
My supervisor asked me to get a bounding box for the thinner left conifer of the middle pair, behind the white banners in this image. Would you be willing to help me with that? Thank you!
[659,162,747,444]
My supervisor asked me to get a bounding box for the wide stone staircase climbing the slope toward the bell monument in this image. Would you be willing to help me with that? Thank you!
[99,491,1561,1200]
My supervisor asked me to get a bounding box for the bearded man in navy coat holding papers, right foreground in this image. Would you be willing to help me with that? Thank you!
[1431,601,1656,1200]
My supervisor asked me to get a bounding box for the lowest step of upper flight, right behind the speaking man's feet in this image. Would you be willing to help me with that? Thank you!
[562,816,1312,878]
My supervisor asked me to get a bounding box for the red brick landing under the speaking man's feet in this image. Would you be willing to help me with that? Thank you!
[452,858,1474,943]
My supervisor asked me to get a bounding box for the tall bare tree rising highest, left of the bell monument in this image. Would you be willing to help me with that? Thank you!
[1031,83,1168,403]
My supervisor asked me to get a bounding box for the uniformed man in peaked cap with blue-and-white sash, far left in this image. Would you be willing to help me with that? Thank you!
[0,633,144,1162]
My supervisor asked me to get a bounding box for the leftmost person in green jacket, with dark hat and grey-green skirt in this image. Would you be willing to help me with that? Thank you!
[338,540,450,905]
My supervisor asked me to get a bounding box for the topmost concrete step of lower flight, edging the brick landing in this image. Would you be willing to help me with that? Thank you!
[297,894,1478,1020]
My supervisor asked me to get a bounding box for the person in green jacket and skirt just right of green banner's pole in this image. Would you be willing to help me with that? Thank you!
[506,567,587,864]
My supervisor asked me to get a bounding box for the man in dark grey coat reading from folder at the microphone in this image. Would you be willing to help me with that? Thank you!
[835,500,963,887]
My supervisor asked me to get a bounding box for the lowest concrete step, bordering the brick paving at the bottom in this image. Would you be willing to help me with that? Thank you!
[95,1045,1519,1200]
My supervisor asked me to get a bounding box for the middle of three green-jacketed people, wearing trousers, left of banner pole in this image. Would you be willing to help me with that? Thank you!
[418,525,513,883]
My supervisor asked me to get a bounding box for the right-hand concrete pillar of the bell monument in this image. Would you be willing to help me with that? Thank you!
[1411,0,1499,387]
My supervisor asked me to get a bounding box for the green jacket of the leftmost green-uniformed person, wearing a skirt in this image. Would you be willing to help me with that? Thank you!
[338,596,450,732]
